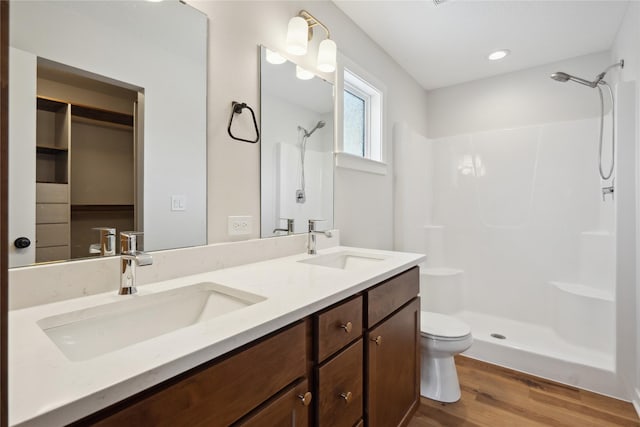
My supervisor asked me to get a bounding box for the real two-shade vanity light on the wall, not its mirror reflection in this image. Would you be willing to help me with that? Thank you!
[287,10,337,73]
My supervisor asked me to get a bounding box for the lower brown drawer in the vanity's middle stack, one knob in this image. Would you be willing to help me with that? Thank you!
[318,339,363,427]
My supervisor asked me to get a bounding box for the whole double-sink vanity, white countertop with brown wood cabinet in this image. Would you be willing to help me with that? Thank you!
[7,247,423,427]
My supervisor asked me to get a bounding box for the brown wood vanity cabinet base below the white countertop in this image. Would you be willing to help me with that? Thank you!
[72,267,420,427]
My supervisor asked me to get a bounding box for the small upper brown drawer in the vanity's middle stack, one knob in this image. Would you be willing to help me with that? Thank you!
[317,296,362,362]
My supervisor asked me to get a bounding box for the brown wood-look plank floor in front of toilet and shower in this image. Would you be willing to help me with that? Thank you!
[409,356,640,427]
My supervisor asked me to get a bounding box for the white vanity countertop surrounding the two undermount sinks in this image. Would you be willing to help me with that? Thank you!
[9,246,424,427]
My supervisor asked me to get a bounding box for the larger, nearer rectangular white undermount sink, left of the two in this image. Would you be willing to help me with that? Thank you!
[38,282,266,361]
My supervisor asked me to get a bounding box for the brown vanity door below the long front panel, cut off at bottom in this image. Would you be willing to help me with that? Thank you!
[238,380,313,427]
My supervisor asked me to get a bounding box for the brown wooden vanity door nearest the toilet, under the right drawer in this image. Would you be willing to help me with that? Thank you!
[365,298,420,427]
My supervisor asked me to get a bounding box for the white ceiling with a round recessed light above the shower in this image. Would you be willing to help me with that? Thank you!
[333,0,628,89]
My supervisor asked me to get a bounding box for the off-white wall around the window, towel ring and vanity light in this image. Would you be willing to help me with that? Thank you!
[189,1,426,248]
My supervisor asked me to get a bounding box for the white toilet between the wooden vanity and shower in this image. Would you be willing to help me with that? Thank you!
[420,311,473,403]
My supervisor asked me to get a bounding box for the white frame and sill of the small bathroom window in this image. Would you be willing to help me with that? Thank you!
[336,56,387,175]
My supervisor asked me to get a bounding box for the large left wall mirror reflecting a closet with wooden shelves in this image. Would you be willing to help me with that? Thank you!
[9,0,207,267]
